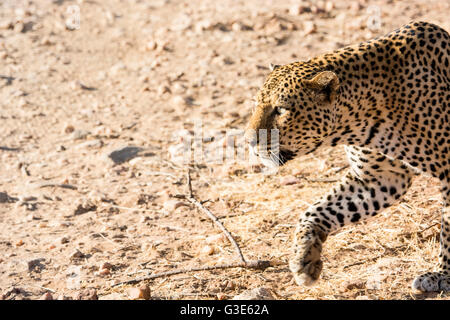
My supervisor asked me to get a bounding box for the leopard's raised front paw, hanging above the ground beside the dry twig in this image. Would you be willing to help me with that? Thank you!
[289,228,326,286]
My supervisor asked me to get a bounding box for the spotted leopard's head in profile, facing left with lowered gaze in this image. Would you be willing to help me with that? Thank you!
[245,62,339,166]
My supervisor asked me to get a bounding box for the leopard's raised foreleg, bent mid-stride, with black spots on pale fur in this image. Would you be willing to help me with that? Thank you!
[289,147,415,285]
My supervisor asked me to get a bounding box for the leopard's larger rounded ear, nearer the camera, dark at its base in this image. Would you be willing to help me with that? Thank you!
[304,71,339,102]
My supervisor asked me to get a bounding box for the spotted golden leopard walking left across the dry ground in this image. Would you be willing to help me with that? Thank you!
[244,21,450,292]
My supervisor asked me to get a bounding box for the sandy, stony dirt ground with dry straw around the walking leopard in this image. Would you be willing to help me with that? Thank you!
[0,0,450,299]
